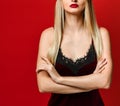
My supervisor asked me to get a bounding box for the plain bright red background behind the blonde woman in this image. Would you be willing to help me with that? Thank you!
[0,0,120,106]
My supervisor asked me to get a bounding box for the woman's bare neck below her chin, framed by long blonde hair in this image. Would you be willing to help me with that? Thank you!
[64,13,84,33]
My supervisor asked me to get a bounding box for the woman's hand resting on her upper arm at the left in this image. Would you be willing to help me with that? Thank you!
[40,57,61,83]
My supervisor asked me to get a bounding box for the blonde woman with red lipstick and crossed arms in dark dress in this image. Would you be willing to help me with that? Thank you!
[36,0,112,106]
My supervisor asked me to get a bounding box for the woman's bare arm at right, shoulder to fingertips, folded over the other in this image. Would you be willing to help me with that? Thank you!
[39,28,113,89]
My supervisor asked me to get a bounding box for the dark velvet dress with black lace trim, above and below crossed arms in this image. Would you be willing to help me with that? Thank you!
[48,41,104,106]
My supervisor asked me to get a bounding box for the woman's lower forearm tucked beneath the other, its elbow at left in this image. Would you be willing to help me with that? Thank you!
[37,71,91,94]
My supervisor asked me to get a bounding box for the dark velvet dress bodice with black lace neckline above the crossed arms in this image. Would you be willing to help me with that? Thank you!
[55,43,97,76]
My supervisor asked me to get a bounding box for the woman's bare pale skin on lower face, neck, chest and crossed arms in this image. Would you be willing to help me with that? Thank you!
[37,0,112,94]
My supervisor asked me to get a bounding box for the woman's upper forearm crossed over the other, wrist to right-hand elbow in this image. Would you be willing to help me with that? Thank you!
[58,73,106,89]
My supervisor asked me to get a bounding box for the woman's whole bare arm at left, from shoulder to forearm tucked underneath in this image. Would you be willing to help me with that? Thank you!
[36,28,91,94]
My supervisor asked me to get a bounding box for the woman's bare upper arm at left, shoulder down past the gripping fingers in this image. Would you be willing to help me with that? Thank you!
[36,27,54,72]
